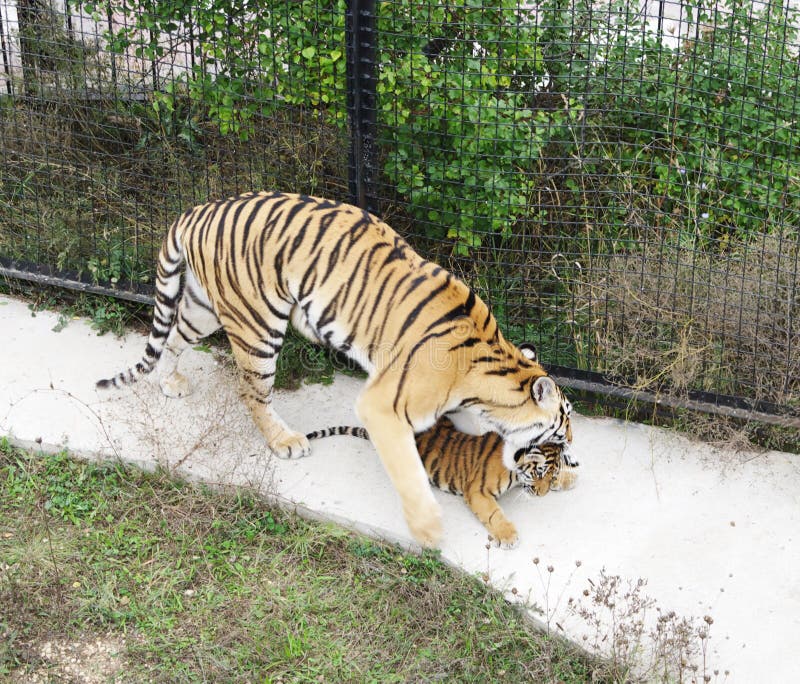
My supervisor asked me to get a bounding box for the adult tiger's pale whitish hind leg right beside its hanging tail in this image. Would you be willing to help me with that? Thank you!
[159,276,221,397]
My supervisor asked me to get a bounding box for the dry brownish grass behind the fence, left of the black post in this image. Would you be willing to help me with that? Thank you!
[0,93,347,283]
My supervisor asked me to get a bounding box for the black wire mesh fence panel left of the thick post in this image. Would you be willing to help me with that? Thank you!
[0,0,347,290]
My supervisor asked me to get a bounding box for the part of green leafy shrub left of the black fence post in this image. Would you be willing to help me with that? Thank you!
[83,0,346,135]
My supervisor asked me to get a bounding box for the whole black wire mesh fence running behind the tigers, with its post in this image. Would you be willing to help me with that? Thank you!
[0,0,800,426]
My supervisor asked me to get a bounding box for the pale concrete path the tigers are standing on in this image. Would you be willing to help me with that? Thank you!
[0,296,800,683]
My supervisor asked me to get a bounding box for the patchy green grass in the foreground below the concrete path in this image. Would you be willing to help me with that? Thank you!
[0,441,593,682]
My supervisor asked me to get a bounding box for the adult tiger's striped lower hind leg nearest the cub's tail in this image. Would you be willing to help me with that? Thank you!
[229,332,311,458]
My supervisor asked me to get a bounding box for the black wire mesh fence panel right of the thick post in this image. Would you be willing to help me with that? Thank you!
[378,0,800,416]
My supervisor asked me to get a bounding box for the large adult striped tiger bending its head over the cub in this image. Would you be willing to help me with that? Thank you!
[97,192,561,546]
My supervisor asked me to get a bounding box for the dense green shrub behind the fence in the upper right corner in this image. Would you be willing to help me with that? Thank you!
[542,0,800,251]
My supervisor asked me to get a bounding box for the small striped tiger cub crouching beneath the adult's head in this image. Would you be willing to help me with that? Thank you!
[306,392,578,548]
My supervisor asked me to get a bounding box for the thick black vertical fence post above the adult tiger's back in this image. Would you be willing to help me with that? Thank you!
[346,0,378,214]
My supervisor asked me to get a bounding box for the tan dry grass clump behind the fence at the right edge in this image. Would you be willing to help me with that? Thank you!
[576,235,800,438]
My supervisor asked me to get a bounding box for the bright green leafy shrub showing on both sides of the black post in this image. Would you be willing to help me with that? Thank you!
[73,0,580,251]
